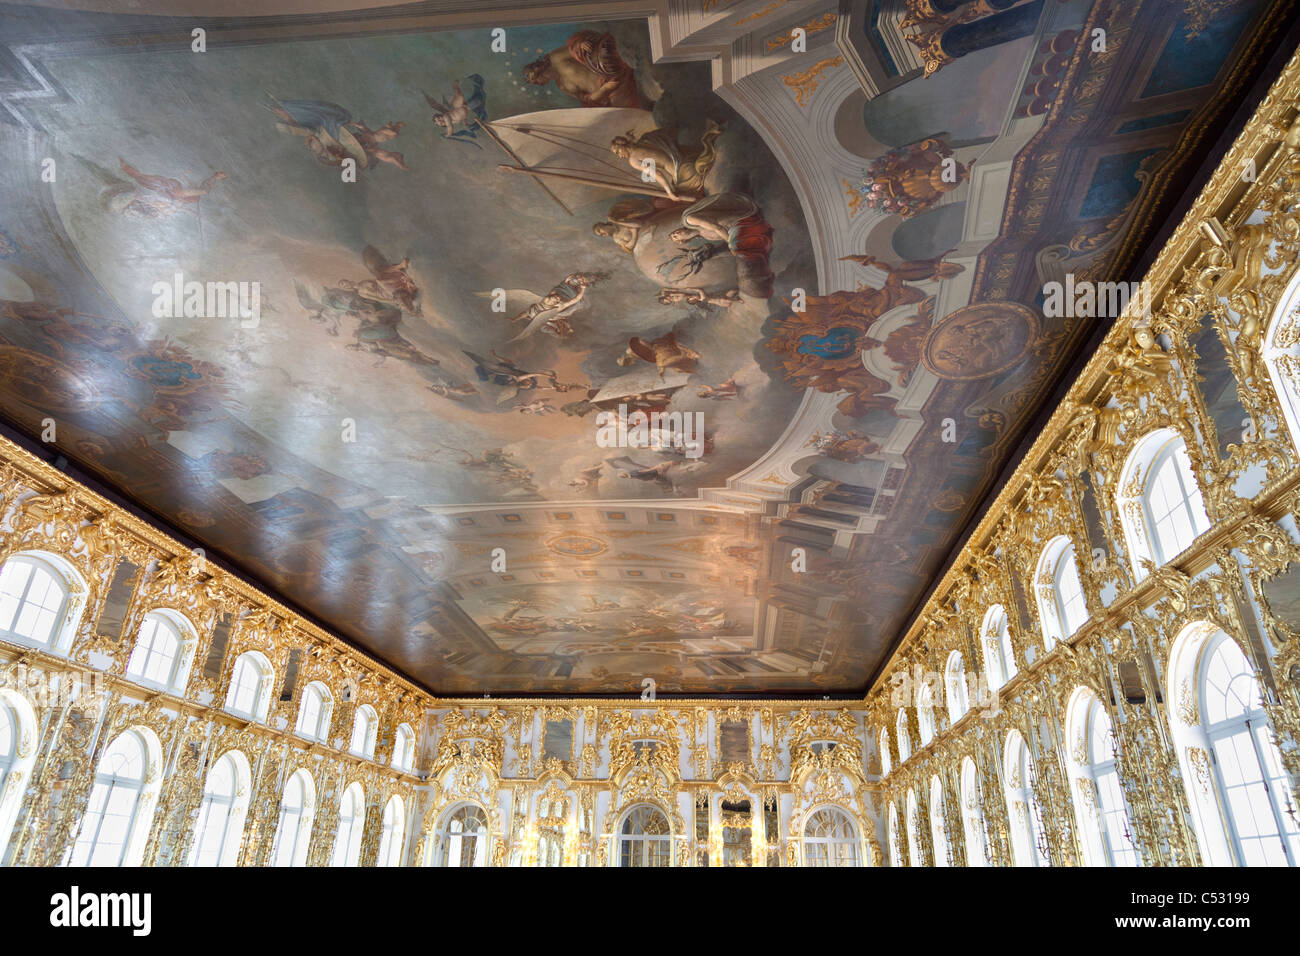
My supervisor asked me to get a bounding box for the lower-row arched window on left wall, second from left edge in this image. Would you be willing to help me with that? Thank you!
[69,727,163,866]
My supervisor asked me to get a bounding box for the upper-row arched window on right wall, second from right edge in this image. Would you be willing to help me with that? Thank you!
[1119,428,1210,580]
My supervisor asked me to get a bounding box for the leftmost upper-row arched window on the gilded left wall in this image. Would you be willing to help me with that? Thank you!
[0,551,86,653]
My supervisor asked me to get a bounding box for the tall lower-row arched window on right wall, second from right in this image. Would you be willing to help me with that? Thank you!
[1066,687,1139,866]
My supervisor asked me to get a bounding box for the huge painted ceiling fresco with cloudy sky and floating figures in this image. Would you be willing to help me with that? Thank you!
[0,1,1279,695]
